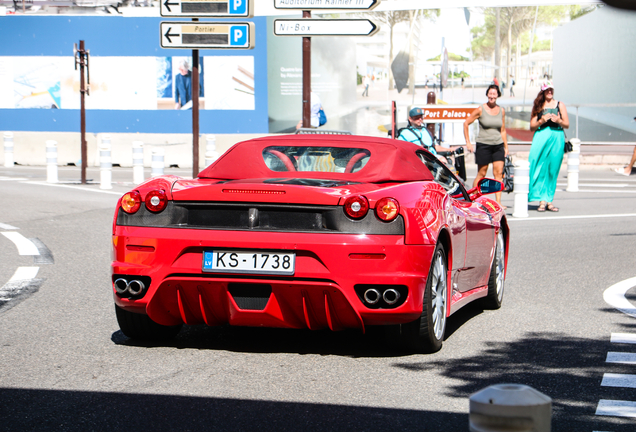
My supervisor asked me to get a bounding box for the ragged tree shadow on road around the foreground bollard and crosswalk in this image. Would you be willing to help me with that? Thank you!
[392,333,634,432]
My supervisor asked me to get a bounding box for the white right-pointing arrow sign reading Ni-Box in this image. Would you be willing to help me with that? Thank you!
[274,19,379,36]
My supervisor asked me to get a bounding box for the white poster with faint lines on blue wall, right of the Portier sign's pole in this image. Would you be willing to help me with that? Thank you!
[204,56,256,110]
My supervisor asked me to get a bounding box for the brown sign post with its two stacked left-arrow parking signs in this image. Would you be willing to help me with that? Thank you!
[159,0,254,178]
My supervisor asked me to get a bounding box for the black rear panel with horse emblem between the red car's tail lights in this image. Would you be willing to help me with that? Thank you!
[117,201,404,235]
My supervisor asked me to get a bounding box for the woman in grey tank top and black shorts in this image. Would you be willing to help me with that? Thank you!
[464,85,508,208]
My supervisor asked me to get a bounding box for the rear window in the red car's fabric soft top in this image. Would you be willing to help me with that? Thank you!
[263,146,371,173]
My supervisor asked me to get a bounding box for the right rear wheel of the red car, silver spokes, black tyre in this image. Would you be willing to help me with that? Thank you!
[402,244,448,353]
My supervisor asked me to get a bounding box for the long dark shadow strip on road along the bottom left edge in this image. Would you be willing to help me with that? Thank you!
[0,388,468,432]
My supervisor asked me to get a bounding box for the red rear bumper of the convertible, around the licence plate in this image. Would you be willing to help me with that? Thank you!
[112,227,434,330]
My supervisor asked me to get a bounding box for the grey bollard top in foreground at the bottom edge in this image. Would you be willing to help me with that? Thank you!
[468,384,552,432]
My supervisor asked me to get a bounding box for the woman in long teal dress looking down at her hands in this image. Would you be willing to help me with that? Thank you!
[528,81,570,212]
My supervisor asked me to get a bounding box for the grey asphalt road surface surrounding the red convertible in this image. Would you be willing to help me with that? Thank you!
[0,167,636,432]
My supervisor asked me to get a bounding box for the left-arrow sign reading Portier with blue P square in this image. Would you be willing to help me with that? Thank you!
[160,21,254,49]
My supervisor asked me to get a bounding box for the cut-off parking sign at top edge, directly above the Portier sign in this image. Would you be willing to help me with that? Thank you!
[160,0,254,18]
